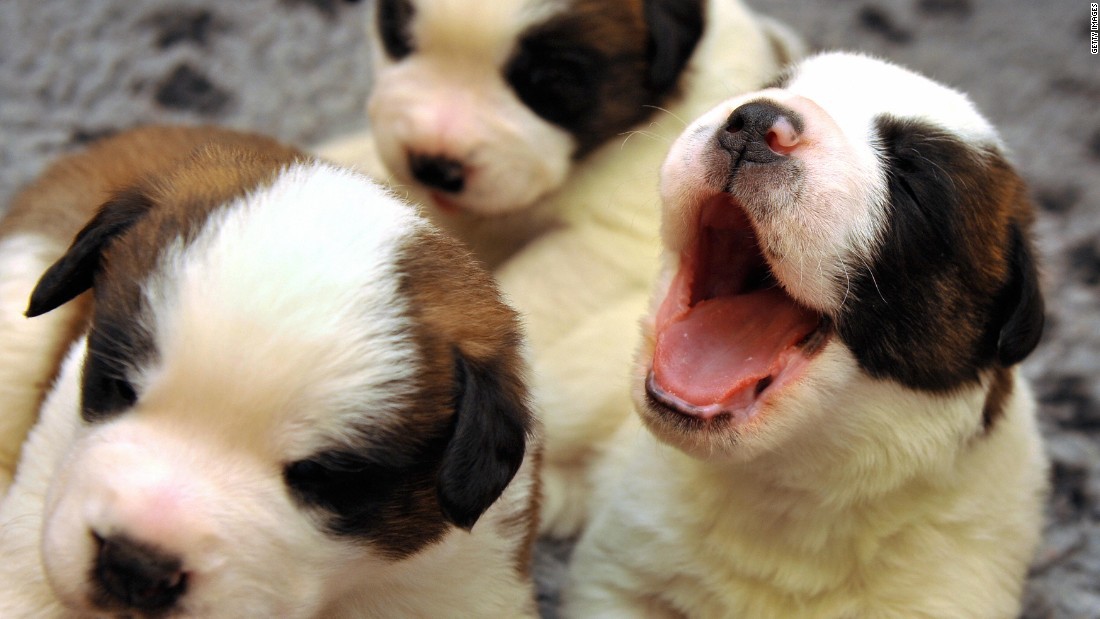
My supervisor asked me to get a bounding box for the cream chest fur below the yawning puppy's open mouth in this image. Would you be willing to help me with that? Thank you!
[567,365,1045,619]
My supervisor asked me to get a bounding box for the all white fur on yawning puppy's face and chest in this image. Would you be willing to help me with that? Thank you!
[567,55,1046,619]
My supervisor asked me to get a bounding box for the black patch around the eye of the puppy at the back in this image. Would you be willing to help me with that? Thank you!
[506,45,600,126]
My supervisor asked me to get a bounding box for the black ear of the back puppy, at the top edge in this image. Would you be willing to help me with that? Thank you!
[644,0,704,92]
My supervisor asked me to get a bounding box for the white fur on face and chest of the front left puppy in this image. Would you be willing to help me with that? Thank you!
[0,164,535,618]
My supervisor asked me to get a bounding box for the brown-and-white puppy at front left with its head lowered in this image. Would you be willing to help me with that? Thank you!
[0,129,538,617]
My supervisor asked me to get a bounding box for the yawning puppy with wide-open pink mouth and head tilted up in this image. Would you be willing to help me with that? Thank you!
[569,53,1047,618]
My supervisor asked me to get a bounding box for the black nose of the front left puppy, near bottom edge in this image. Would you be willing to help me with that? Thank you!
[92,535,187,612]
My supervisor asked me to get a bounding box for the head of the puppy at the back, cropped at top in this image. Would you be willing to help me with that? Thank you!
[367,0,703,215]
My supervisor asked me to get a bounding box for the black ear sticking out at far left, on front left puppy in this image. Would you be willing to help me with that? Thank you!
[26,190,151,318]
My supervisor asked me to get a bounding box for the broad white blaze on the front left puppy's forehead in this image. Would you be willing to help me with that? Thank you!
[138,163,421,451]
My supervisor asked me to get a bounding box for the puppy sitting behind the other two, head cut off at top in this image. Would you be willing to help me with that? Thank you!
[320,0,801,535]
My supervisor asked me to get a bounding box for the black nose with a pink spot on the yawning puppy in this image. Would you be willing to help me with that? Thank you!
[718,100,802,164]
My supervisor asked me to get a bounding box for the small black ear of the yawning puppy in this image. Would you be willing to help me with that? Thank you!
[997,225,1045,367]
